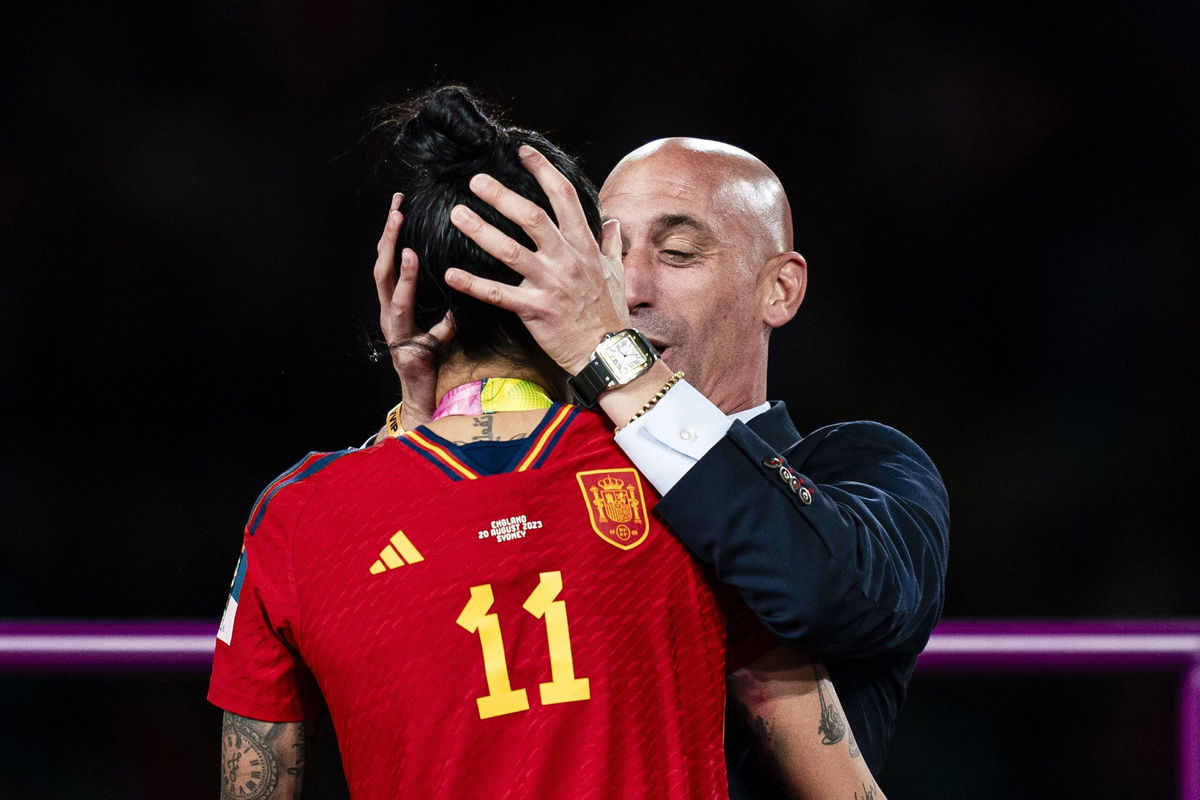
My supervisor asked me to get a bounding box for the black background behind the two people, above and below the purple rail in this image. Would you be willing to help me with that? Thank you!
[0,0,1200,800]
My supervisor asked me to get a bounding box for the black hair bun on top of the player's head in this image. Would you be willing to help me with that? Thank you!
[395,86,508,176]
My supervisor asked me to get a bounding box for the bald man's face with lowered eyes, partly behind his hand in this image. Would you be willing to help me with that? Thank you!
[600,151,774,411]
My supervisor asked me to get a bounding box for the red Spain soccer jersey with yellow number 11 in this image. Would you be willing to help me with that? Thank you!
[209,405,727,800]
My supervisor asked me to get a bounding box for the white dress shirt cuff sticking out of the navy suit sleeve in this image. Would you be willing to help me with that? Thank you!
[616,380,733,494]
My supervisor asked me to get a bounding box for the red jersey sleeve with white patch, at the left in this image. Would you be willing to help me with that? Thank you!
[209,460,322,722]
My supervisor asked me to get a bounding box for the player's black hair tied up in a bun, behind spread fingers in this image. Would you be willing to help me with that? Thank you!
[380,86,600,361]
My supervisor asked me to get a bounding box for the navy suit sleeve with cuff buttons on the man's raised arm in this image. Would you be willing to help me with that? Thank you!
[656,422,949,657]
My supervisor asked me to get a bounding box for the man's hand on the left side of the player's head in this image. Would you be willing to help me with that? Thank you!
[374,193,454,431]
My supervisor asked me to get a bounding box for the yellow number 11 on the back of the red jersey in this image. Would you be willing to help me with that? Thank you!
[458,571,592,720]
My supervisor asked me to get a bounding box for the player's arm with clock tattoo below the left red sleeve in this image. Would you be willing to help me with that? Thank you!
[221,711,311,800]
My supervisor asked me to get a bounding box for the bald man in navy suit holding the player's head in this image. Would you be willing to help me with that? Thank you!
[383,138,949,798]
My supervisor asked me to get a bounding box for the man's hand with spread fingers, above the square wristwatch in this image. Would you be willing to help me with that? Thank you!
[446,145,629,374]
